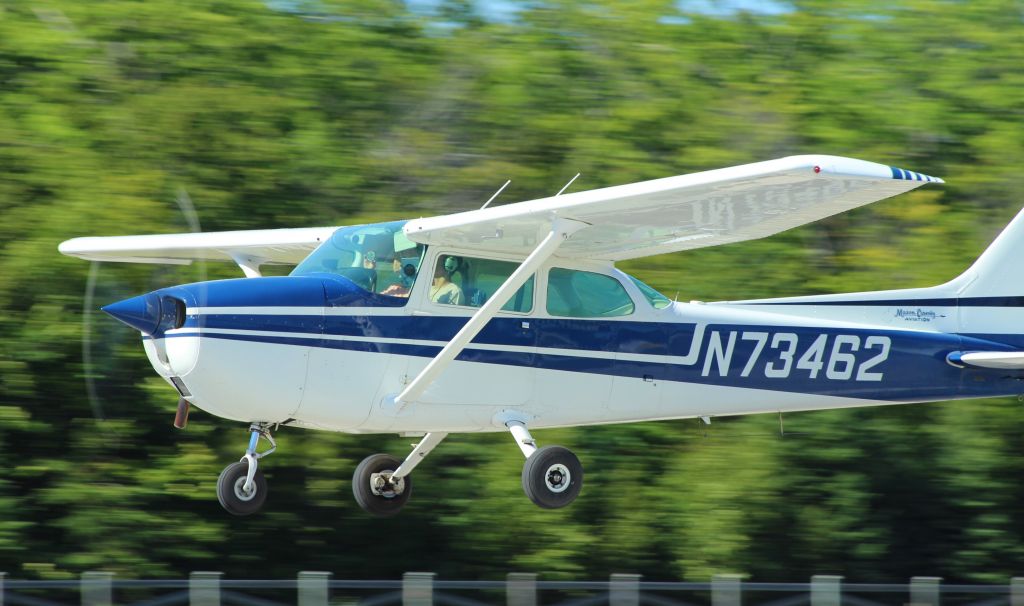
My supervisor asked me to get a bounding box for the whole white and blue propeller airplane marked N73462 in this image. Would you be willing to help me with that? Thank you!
[59,156,1024,516]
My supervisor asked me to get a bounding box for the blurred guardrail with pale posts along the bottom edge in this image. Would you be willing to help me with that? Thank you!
[0,572,1024,606]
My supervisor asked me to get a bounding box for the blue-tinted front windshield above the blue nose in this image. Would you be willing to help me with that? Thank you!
[291,221,426,297]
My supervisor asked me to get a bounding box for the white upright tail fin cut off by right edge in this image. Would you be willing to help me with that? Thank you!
[945,205,1024,300]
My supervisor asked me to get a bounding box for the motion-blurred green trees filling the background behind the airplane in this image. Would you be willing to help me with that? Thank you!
[0,0,1024,581]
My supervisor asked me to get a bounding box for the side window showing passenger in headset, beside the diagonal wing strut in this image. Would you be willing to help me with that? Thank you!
[430,255,535,313]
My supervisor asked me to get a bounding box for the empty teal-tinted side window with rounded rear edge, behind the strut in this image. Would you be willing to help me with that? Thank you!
[548,267,635,317]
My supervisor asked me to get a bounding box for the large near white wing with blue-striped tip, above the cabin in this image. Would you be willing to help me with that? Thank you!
[404,156,943,261]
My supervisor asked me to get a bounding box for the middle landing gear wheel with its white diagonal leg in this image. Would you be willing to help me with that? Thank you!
[352,432,447,518]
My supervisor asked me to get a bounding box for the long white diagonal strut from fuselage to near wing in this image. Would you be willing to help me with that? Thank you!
[394,217,587,413]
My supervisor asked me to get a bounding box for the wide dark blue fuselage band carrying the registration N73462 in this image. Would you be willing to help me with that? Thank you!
[161,313,1020,401]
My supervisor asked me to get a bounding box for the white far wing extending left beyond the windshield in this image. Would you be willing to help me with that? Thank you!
[58,227,337,275]
